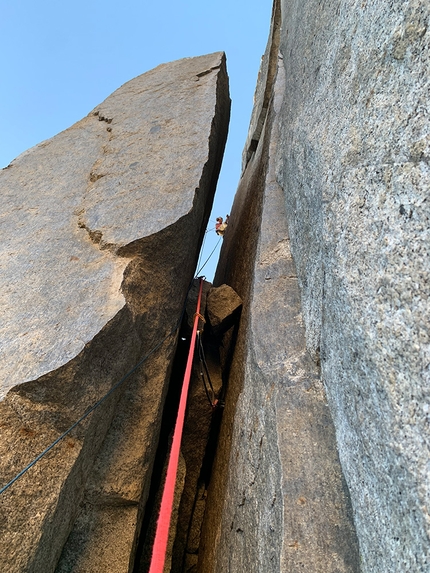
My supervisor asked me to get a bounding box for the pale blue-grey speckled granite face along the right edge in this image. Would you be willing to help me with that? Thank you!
[278,0,430,573]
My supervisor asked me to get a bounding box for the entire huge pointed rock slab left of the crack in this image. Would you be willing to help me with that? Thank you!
[0,53,230,573]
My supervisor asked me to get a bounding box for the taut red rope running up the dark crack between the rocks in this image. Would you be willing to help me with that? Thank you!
[149,278,203,573]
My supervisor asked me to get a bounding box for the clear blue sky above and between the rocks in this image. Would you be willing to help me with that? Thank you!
[0,0,272,280]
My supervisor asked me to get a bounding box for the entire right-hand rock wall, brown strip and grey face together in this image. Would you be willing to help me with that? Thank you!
[199,0,430,573]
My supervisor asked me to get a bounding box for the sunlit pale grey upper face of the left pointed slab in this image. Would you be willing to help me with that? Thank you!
[0,54,228,396]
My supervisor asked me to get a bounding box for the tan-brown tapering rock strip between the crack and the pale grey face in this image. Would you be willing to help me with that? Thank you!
[198,39,360,573]
